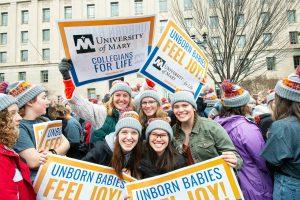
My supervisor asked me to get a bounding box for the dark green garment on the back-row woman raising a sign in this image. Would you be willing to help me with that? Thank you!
[92,109,120,143]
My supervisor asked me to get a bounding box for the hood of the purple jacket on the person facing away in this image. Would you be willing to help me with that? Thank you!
[214,115,250,132]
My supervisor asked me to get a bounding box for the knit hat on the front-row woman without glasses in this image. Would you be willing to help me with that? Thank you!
[115,111,142,136]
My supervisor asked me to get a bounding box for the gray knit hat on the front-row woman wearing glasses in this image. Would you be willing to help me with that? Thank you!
[146,118,174,140]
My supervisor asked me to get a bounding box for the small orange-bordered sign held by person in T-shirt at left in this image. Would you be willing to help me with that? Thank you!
[33,120,62,152]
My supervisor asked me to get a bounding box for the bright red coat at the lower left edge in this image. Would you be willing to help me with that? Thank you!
[0,144,36,200]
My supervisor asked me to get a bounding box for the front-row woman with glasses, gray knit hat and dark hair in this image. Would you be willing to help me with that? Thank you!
[140,118,187,178]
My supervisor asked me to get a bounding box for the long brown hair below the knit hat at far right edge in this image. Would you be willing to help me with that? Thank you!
[272,94,300,121]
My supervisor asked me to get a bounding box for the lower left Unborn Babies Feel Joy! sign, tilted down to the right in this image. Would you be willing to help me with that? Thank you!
[33,155,135,200]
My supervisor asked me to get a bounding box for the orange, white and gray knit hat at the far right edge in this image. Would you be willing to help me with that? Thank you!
[275,66,300,102]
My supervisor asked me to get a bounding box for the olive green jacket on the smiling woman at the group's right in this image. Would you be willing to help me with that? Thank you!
[173,115,243,169]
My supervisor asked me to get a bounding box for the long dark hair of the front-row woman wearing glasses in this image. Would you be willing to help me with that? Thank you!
[144,133,179,172]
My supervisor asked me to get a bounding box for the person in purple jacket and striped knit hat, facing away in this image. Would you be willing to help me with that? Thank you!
[215,80,272,200]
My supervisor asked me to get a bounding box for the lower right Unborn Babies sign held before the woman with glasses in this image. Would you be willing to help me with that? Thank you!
[126,157,243,200]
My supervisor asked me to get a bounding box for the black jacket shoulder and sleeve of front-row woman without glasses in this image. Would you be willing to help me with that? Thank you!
[82,140,113,166]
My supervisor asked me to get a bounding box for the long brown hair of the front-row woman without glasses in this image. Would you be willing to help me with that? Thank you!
[111,134,142,179]
